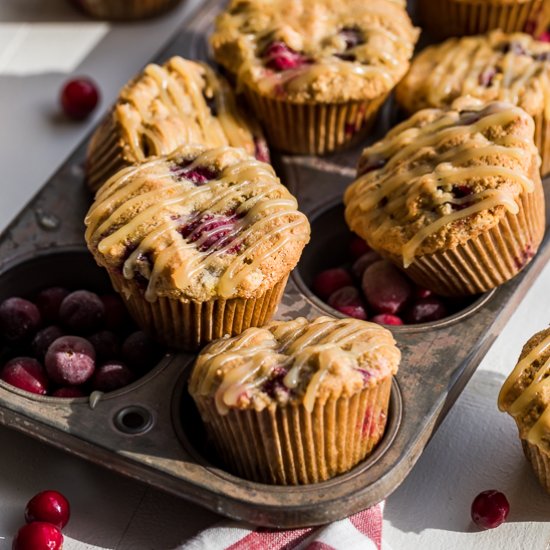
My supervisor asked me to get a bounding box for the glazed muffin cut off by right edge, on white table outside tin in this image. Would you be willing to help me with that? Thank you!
[498,328,550,493]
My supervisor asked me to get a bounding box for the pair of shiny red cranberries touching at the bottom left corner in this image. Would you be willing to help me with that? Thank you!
[12,491,71,550]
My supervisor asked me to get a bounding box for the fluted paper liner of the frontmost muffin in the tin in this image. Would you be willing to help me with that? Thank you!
[193,376,392,485]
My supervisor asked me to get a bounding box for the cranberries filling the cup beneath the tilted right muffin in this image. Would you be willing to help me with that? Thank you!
[313,237,472,325]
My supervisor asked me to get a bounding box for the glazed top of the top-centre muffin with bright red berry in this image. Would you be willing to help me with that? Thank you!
[211,0,418,103]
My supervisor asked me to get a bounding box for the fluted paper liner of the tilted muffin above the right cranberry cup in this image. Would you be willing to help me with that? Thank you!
[390,181,545,296]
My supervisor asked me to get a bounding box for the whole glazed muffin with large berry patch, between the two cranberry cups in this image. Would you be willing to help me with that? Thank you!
[86,145,309,349]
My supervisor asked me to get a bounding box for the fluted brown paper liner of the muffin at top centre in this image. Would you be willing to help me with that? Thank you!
[244,86,389,155]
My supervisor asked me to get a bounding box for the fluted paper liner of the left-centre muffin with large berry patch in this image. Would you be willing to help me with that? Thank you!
[109,272,288,350]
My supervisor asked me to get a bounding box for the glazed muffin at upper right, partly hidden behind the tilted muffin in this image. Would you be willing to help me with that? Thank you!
[395,31,550,174]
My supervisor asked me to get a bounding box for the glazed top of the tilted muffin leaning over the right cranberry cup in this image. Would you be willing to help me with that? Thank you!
[344,102,541,267]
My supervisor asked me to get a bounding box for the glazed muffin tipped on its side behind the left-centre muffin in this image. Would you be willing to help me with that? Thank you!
[86,56,269,192]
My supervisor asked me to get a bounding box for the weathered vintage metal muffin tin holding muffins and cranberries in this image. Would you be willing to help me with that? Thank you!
[0,0,550,527]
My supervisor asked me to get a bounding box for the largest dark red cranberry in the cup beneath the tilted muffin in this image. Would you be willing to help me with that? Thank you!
[361,260,412,315]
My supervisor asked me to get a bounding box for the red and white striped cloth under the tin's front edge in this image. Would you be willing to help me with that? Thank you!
[181,502,384,550]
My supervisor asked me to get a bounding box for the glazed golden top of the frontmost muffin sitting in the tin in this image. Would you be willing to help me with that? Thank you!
[189,317,401,414]
